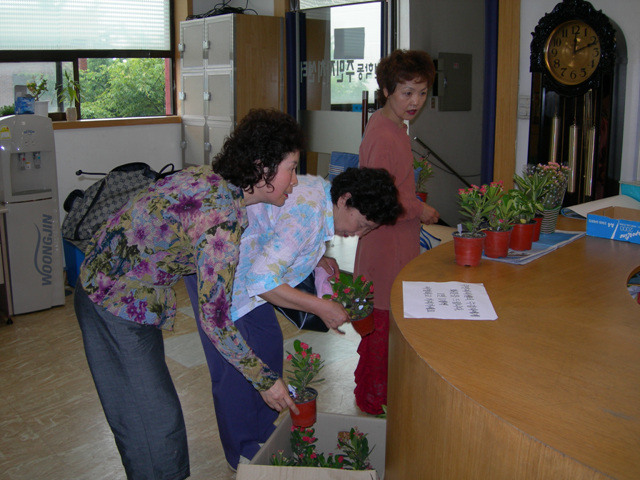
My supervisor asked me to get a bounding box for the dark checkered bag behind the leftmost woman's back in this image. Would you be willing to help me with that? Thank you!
[61,162,175,253]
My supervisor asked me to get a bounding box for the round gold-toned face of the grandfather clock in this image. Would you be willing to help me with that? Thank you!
[544,20,601,85]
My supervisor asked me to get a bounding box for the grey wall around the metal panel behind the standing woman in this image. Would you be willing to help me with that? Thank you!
[400,0,485,225]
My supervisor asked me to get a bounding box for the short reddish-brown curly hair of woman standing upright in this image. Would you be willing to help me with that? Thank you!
[376,50,436,106]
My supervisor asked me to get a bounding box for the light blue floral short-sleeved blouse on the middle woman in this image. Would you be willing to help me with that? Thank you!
[231,175,334,321]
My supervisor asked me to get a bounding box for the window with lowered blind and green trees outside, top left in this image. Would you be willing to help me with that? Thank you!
[0,0,174,118]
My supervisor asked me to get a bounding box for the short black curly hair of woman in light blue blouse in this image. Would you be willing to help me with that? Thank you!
[331,168,404,225]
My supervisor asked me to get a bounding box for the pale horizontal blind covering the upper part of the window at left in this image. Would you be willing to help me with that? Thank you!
[0,0,171,51]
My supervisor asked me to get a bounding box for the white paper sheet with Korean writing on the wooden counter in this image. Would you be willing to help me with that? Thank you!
[402,282,498,320]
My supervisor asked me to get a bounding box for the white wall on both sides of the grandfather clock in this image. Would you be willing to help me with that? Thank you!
[516,0,640,181]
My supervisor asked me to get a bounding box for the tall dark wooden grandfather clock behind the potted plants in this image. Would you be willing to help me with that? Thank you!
[528,0,619,205]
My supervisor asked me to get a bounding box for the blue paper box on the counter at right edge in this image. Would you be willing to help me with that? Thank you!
[587,207,640,244]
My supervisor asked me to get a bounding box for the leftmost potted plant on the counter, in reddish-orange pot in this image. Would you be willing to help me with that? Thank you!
[453,185,497,267]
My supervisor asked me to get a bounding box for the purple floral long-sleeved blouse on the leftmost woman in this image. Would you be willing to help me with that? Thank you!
[80,166,278,390]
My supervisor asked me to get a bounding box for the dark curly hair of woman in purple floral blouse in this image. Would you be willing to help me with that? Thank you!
[212,109,305,193]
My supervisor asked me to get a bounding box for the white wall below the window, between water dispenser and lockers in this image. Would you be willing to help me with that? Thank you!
[54,123,182,221]
